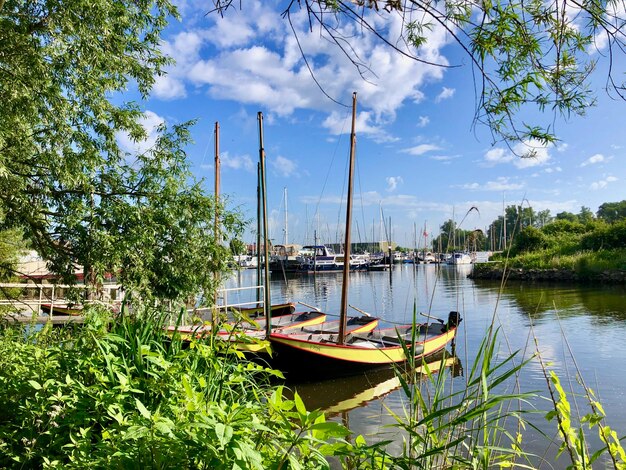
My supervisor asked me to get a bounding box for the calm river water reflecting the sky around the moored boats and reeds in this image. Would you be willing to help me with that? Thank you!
[222,264,626,468]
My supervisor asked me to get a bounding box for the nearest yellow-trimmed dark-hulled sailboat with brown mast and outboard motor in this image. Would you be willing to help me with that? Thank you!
[269,93,461,378]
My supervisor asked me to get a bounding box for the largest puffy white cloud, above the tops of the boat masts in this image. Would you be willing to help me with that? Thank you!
[154,0,454,136]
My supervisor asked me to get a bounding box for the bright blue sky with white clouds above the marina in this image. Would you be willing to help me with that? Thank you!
[119,1,626,250]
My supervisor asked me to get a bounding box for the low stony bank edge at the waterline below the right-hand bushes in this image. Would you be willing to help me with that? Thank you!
[468,262,626,284]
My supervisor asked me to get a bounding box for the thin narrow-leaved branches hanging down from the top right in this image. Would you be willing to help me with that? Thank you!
[214,0,626,146]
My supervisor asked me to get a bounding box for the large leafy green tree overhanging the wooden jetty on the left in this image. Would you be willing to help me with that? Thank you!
[0,0,241,298]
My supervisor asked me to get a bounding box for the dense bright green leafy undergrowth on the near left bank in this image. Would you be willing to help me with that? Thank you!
[0,309,360,469]
